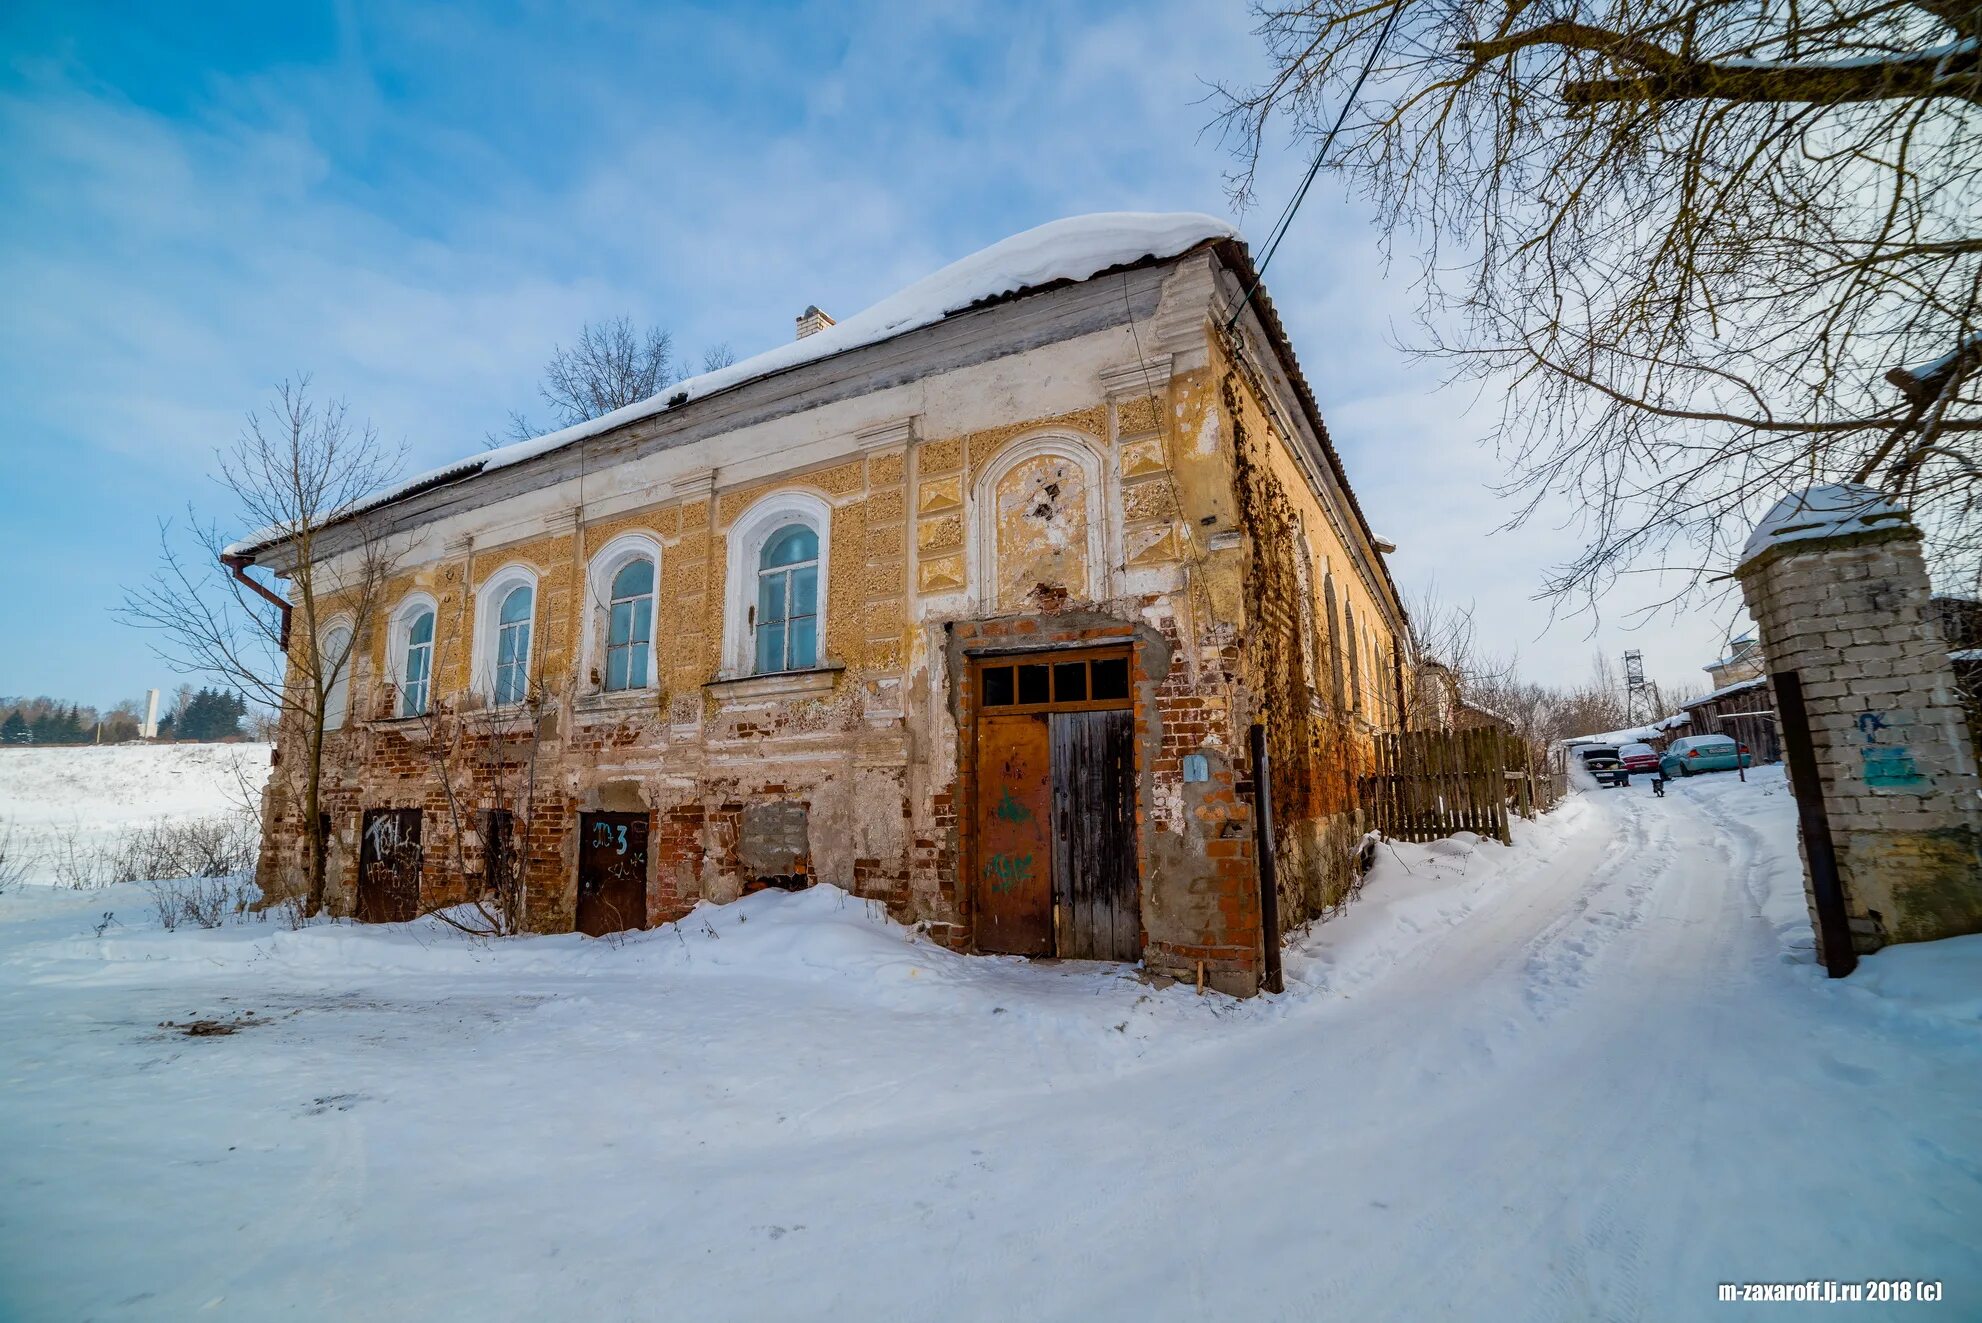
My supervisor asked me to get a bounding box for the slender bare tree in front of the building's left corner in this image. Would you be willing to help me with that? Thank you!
[119,376,398,913]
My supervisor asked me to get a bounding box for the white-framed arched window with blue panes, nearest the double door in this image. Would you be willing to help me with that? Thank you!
[723,491,832,675]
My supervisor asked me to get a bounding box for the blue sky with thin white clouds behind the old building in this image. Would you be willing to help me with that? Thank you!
[0,0,1724,703]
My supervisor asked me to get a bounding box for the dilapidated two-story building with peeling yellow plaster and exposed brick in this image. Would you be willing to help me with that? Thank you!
[236,214,1409,994]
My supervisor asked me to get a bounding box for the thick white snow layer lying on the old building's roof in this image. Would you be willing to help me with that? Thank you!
[226,212,1239,555]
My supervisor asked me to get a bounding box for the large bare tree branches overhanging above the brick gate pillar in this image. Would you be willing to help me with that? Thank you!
[1221,0,1982,600]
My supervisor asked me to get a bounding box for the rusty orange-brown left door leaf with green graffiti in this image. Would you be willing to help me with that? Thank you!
[973,715,1052,955]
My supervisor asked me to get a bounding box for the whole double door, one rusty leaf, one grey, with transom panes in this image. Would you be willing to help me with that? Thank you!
[971,650,1142,961]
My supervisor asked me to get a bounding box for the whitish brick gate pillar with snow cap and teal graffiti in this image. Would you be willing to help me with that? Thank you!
[1734,485,1982,959]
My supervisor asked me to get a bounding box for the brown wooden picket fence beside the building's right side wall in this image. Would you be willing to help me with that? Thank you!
[1362,727,1568,842]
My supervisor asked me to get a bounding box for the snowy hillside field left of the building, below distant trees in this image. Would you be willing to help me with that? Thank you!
[0,745,270,879]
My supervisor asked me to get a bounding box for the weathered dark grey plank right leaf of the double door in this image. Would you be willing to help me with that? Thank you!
[1048,709,1142,961]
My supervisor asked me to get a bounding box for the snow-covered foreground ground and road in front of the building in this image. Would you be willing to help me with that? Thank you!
[0,768,1982,1321]
